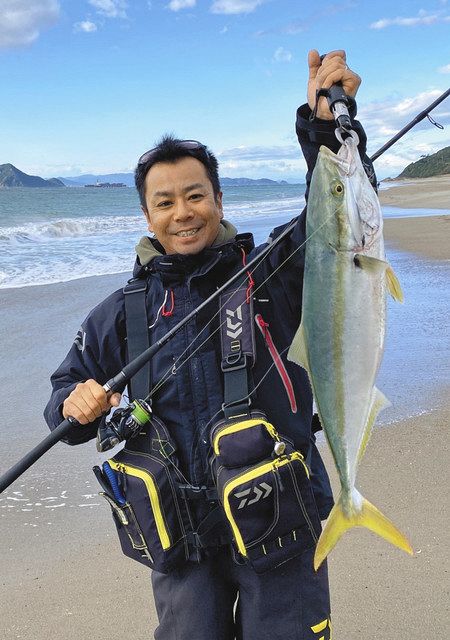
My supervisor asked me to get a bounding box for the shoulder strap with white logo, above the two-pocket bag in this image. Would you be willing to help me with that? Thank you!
[220,286,256,419]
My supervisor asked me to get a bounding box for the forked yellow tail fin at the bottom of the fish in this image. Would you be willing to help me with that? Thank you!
[314,489,414,571]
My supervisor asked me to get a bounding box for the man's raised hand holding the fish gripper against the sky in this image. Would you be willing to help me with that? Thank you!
[308,49,361,120]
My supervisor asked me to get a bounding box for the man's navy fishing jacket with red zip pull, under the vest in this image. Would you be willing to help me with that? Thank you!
[45,105,376,519]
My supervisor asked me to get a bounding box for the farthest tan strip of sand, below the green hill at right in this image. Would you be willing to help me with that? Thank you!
[379,175,450,212]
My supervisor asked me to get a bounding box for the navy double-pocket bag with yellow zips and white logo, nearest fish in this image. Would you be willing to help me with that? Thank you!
[211,411,321,573]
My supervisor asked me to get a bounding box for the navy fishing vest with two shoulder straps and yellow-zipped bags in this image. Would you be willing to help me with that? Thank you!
[95,279,320,573]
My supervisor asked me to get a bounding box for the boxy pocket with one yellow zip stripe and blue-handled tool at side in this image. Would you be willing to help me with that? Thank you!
[96,448,188,573]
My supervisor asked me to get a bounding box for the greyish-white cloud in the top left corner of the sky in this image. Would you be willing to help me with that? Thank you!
[0,0,59,48]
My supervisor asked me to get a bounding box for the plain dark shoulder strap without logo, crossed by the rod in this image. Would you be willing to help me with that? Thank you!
[123,278,151,399]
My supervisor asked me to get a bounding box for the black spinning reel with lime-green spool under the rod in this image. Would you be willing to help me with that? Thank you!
[97,400,152,451]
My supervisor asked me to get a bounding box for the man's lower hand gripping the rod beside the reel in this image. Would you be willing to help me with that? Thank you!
[62,380,120,424]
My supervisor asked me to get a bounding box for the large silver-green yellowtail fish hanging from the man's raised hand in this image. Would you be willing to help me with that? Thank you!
[288,133,413,569]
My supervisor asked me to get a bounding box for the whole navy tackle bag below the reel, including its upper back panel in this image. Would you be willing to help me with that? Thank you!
[94,415,192,573]
